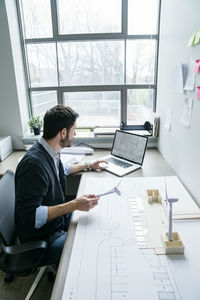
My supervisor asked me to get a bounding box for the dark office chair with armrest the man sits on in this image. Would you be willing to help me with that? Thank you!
[0,170,55,300]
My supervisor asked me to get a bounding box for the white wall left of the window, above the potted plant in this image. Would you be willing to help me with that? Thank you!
[0,0,28,148]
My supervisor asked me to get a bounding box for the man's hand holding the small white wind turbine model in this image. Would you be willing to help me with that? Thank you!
[73,194,99,211]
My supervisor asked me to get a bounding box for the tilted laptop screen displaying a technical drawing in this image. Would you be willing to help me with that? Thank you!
[111,130,148,165]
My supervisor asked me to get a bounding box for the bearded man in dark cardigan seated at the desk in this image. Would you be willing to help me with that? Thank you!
[15,105,103,265]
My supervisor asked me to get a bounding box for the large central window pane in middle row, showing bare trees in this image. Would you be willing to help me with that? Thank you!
[58,41,124,86]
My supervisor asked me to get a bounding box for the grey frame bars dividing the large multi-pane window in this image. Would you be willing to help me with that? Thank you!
[16,0,161,129]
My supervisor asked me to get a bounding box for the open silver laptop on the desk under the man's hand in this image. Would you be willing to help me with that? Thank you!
[102,130,148,176]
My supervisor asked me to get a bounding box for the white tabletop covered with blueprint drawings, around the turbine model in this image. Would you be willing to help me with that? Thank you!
[57,177,200,300]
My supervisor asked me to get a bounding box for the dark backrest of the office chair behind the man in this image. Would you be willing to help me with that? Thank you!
[0,170,16,246]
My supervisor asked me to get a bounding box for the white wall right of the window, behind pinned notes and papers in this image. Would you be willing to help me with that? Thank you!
[157,0,200,204]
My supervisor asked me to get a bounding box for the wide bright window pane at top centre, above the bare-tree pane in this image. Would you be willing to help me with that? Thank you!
[57,0,122,34]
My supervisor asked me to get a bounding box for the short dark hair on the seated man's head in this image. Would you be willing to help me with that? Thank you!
[43,104,79,140]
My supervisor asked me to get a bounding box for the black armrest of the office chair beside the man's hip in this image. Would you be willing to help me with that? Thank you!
[2,241,47,255]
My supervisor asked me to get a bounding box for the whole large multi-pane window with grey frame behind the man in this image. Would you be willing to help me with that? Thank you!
[16,0,160,127]
